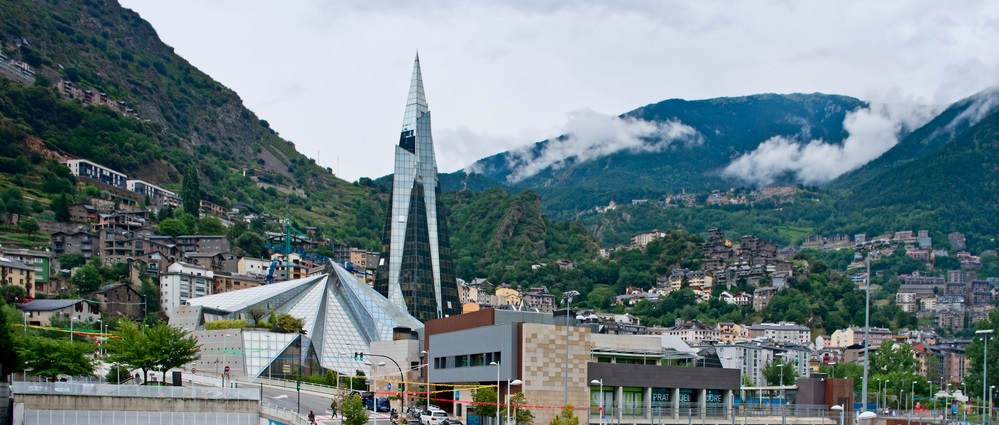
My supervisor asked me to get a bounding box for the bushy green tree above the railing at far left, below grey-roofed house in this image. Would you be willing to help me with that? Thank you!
[18,336,94,380]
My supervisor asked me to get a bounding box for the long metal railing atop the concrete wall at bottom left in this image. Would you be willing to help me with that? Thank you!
[12,382,260,400]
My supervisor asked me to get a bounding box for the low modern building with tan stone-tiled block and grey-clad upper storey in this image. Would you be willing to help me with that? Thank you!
[424,309,739,423]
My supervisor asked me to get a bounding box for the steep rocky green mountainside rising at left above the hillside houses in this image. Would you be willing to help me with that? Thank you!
[0,0,385,248]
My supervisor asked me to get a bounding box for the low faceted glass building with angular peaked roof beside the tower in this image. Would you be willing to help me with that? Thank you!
[188,264,423,377]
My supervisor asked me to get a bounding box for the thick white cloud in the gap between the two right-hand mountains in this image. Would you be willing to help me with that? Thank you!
[722,103,936,186]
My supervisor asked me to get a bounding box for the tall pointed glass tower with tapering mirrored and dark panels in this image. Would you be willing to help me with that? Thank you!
[375,54,461,322]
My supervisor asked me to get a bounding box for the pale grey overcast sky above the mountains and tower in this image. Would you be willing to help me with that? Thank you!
[121,0,999,181]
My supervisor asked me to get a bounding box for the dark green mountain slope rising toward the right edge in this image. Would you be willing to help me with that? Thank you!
[829,107,999,242]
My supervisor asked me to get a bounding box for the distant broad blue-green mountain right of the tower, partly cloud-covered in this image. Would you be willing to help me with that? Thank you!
[459,93,865,218]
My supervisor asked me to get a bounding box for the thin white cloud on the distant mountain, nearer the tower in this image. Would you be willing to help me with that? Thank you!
[506,109,703,183]
